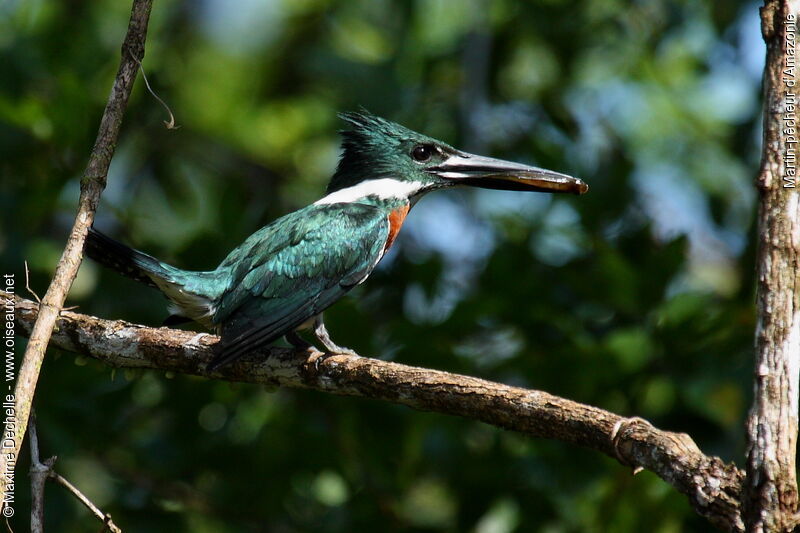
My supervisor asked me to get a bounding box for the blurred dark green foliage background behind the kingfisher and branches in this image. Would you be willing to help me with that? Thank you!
[0,0,763,533]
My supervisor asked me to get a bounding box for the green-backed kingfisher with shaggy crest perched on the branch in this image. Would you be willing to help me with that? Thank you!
[85,111,588,370]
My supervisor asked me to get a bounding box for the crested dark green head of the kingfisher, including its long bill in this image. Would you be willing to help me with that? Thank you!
[328,112,589,196]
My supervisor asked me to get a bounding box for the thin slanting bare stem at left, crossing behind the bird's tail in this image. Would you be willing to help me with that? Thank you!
[0,0,152,501]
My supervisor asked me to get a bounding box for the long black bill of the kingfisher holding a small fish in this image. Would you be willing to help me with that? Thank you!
[427,152,589,194]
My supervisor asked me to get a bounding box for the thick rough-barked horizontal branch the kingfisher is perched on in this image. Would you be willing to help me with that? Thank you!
[16,298,743,531]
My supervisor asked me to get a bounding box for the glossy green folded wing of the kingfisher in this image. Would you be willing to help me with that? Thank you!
[211,204,389,368]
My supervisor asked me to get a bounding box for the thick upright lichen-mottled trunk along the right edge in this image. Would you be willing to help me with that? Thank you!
[743,0,800,532]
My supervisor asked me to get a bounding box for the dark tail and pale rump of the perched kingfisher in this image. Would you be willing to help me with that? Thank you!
[83,228,221,327]
